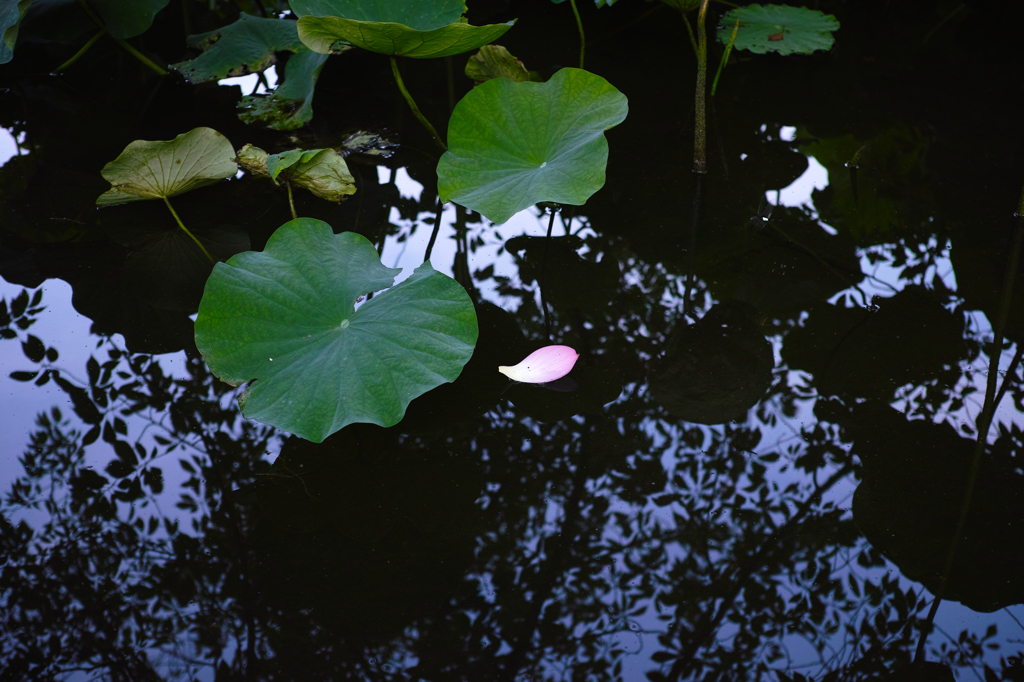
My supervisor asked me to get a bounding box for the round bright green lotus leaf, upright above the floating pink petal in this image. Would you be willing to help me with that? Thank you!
[437,69,629,223]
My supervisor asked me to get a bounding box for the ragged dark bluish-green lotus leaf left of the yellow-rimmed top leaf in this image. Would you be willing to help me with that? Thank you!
[170,14,306,83]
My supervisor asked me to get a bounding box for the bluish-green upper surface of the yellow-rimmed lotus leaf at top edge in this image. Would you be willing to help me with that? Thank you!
[291,0,466,31]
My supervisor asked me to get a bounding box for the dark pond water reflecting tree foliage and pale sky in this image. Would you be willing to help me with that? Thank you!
[0,0,1024,682]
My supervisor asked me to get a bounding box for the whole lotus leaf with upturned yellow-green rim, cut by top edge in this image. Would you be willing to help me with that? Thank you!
[292,0,514,57]
